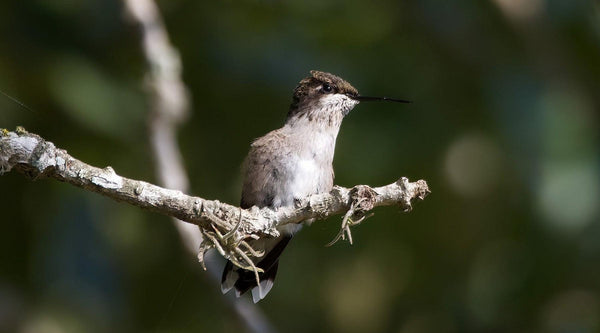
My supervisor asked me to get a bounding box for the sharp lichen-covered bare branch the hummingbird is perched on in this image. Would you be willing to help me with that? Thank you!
[0,128,430,252]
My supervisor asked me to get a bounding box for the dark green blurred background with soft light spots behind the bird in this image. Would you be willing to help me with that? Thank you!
[0,0,600,333]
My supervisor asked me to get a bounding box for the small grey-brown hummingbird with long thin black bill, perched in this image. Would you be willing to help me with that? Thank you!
[221,70,410,303]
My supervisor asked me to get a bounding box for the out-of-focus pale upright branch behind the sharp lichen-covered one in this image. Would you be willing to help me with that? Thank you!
[124,0,274,333]
